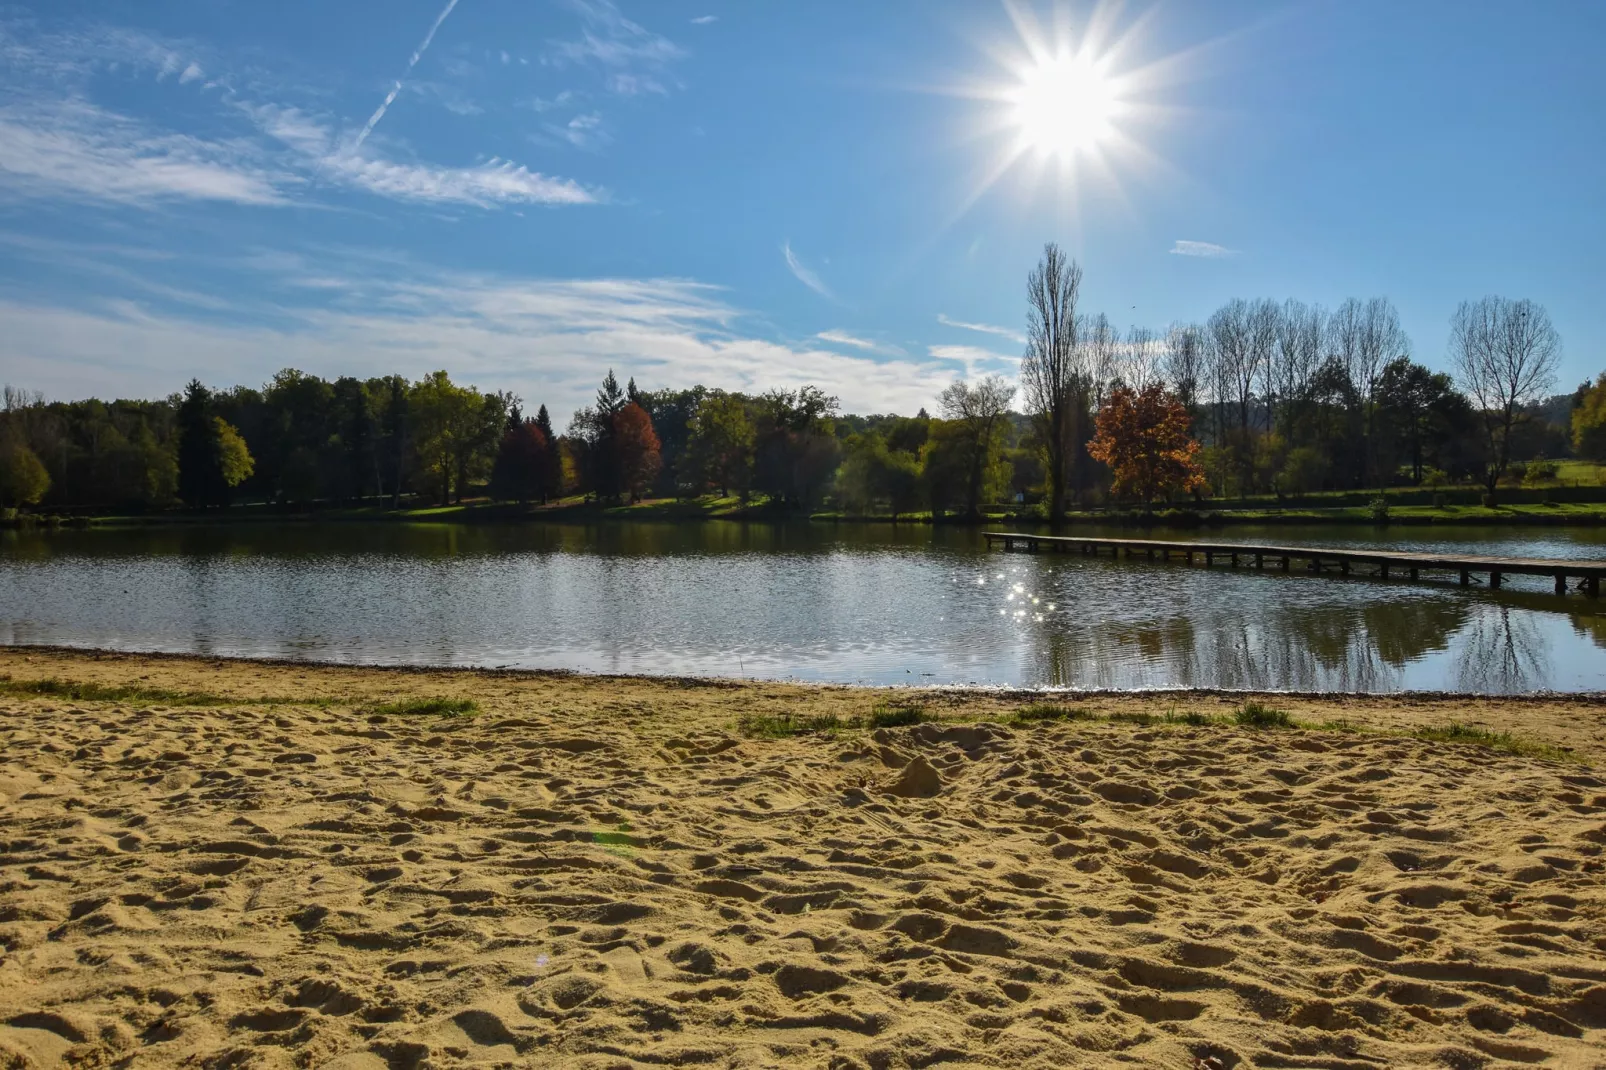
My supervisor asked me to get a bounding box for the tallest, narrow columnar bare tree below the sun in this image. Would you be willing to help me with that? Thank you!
[1020,241,1092,519]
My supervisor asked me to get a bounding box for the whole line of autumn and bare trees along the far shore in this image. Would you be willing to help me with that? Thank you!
[0,244,1606,516]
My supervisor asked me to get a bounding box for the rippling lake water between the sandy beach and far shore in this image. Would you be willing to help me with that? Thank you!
[0,522,1606,692]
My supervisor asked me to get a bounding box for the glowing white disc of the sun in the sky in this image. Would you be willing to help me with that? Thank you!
[1007,53,1119,159]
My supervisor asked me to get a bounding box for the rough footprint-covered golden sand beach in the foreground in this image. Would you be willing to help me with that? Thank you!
[0,649,1606,1070]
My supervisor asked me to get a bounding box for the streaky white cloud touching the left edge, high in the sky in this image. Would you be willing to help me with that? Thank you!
[0,100,284,204]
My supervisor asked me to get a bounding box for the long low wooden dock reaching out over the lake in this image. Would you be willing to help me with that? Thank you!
[983,532,1606,598]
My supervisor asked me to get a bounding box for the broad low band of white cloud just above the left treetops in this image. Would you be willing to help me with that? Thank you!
[0,249,965,413]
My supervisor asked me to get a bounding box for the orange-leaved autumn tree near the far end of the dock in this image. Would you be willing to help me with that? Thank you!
[1087,382,1205,506]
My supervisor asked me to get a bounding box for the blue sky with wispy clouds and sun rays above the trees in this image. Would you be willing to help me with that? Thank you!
[0,0,1606,415]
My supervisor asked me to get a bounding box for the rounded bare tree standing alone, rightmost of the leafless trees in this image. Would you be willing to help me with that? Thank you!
[1450,297,1561,496]
